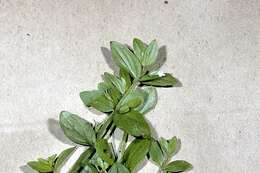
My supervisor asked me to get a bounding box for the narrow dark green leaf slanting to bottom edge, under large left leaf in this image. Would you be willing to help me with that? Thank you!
[69,147,95,173]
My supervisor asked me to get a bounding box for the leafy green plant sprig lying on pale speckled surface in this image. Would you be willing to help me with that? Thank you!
[28,39,192,173]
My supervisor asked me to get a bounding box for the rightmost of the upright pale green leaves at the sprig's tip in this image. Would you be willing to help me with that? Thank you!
[141,40,159,66]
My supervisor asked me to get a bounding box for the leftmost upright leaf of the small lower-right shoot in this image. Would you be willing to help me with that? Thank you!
[149,140,164,166]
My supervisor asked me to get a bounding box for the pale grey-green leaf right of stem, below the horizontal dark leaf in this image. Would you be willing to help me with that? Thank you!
[138,87,157,114]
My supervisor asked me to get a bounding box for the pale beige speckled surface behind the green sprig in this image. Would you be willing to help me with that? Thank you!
[0,0,260,173]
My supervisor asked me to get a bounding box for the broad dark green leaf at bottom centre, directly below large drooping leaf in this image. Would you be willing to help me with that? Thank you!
[123,139,151,172]
